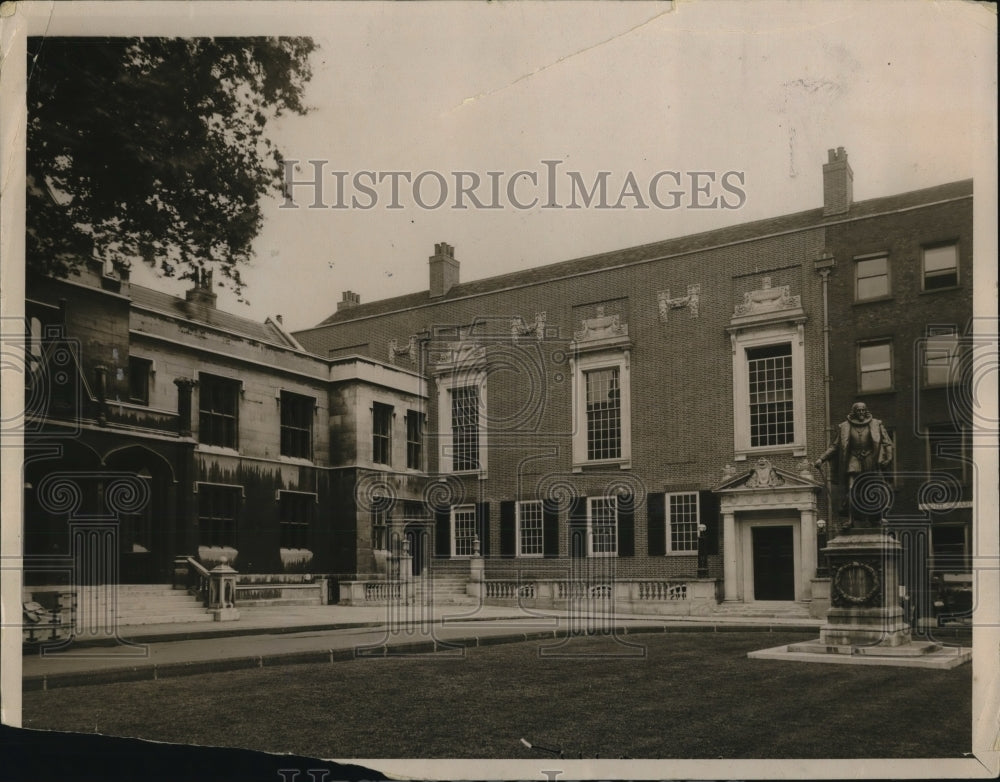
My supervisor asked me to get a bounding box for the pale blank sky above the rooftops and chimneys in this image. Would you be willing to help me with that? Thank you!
[9,0,996,329]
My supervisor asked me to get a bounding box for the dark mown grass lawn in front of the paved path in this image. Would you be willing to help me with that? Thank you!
[23,633,972,759]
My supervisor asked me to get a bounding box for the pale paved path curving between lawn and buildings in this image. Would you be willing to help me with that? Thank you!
[22,604,822,690]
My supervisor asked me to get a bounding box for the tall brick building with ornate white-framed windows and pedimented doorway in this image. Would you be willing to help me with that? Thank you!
[295,149,972,620]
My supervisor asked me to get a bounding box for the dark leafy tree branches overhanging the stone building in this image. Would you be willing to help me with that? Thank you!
[27,38,315,292]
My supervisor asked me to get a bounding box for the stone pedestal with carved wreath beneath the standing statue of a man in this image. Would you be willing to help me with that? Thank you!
[820,530,910,646]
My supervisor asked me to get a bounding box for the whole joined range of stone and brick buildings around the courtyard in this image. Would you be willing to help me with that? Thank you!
[25,149,973,624]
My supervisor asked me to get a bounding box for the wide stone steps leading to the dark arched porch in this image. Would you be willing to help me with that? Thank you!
[77,584,214,627]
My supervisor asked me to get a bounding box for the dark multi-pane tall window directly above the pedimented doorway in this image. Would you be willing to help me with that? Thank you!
[747,343,795,448]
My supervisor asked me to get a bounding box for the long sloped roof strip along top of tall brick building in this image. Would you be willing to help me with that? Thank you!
[293,179,972,334]
